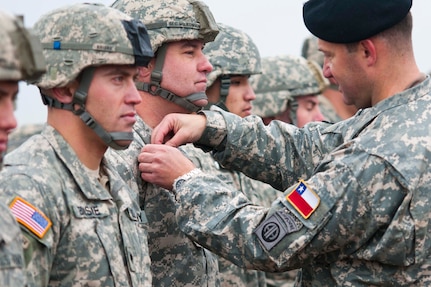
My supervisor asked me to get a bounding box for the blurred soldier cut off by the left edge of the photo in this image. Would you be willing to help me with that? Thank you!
[0,11,45,286]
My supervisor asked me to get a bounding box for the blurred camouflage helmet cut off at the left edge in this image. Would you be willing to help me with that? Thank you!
[0,11,45,81]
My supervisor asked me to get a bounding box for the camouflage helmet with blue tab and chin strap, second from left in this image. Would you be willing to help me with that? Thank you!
[34,3,154,149]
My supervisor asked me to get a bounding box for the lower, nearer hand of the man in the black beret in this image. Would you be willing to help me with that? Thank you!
[138,144,195,190]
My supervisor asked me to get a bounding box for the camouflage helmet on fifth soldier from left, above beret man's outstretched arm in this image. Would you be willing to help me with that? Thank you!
[251,55,329,121]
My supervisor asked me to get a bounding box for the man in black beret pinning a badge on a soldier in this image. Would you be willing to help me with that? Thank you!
[139,0,431,286]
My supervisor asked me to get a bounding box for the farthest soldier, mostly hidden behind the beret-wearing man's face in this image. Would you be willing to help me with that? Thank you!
[301,36,357,123]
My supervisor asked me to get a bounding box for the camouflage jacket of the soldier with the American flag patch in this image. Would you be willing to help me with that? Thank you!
[0,126,151,286]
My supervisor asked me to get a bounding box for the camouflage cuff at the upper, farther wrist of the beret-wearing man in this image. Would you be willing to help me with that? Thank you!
[195,111,227,151]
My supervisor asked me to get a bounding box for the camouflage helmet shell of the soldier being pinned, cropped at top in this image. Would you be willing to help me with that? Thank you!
[111,0,218,52]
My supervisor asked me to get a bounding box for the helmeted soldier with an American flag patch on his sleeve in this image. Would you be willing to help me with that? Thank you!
[0,4,153,286]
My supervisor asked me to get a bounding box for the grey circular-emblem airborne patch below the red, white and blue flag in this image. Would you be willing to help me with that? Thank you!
[254,209,303,251]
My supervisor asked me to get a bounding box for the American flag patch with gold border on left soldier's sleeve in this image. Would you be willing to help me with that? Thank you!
[9,197,52,238]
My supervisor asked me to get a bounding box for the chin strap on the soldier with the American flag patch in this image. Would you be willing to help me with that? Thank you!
[42,67,133,150]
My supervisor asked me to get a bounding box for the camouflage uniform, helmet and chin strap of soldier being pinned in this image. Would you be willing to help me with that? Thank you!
[107,0,223,287]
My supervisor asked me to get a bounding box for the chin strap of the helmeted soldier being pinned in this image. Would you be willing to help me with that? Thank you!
[136,44,208,112]
